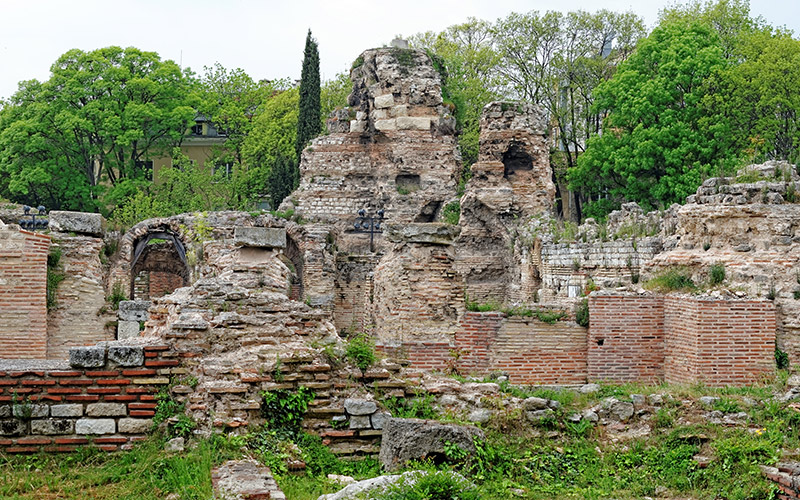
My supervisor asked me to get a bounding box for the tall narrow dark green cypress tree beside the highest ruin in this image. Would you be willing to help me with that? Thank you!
[296,30,322,161]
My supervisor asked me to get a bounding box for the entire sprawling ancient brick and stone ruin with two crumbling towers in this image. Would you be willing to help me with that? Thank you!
[0,48,800,455]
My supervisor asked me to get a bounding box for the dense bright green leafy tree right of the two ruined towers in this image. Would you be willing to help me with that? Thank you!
[569,21,735,208]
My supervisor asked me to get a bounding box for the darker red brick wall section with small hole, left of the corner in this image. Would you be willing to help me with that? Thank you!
[587,294,664,382]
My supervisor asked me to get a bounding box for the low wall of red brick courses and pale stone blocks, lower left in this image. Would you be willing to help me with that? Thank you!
[0,345,178,453]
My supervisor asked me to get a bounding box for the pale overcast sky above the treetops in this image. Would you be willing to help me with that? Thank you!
[0,0,800,98]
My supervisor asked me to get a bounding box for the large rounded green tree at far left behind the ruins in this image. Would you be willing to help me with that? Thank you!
[0,47,195,210]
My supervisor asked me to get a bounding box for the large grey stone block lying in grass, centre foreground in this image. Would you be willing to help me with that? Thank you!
[379,418,484,470]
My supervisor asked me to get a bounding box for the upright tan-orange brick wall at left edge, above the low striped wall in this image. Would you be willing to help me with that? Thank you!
[0,228,50,359]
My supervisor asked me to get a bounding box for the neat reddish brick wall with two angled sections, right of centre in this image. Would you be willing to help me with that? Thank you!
[588,294,776,386]
